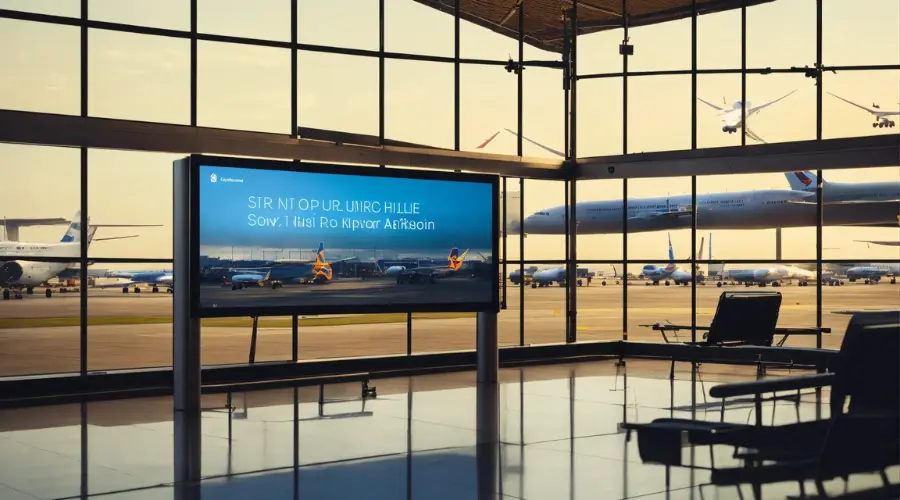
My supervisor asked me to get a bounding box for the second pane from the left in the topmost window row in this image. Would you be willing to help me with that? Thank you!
[88,0,191,30]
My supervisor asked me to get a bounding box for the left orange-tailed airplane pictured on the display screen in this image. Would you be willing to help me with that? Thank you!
[224,241,356,290]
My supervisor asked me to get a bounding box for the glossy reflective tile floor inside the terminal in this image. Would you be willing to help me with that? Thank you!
[0,360,900,500]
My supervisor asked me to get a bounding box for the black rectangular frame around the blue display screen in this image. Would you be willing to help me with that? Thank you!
[181,154,500,318]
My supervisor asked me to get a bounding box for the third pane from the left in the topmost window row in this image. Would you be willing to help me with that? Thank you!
[197,0,291,42]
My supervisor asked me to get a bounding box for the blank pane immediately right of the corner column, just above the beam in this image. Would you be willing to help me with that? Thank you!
[576,78,624,158]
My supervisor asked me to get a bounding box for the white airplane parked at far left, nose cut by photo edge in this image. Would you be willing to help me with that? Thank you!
[0,211,156,300]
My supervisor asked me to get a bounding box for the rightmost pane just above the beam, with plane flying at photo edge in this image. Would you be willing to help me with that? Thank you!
[822,70,900,139]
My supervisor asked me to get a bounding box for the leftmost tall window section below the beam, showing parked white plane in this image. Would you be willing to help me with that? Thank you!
[0,144,82,376]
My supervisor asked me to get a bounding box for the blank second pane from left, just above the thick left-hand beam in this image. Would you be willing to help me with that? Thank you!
[88,30,191,124]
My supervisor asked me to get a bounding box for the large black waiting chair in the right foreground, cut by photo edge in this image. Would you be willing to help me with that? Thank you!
[625,311,900,496]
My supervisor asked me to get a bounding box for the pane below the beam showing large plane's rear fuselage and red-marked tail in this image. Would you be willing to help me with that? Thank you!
[696,172,816,261]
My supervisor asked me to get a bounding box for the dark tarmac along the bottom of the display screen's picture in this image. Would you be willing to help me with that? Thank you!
[200,277,493,308]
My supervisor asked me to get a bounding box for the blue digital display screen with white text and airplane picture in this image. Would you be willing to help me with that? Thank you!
[196,162,499,315]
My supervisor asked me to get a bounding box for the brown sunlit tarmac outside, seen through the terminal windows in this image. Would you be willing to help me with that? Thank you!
[0,282,900,376]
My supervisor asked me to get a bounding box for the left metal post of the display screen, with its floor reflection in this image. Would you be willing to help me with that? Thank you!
[172,159,201,500]
